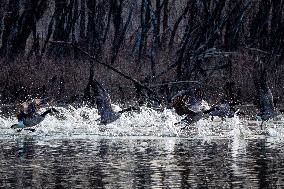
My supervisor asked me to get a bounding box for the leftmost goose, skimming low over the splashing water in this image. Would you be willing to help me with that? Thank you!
[11,98,59,132]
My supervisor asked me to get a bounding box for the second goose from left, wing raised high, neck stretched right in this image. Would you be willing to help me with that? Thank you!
[90,79,138,125]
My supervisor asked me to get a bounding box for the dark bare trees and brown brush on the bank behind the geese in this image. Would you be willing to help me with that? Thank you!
[0,0,284,103]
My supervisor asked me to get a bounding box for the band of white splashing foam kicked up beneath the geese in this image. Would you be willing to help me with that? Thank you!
[0,105,284,142]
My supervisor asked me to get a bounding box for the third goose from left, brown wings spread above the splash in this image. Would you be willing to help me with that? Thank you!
[171,89,209,124]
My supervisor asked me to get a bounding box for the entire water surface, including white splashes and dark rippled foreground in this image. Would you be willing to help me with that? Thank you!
[0,107,284,188]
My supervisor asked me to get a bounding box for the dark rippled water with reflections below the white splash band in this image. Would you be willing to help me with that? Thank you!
[0,137,284,188]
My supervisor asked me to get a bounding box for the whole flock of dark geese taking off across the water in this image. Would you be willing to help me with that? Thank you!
[11,67,280,131]
